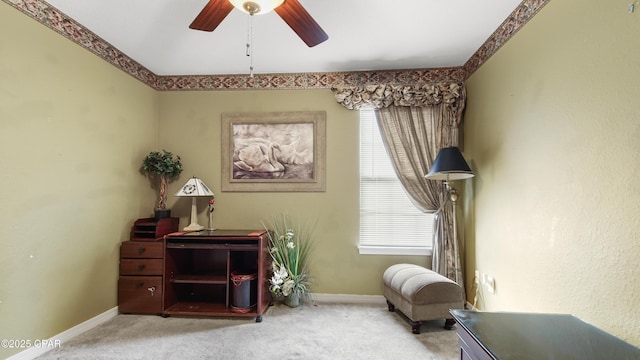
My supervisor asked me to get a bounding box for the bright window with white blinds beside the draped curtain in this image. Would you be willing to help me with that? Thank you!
[358,109,433,255]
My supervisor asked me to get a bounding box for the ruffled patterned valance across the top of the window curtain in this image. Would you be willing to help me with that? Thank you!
[332,83,466,110]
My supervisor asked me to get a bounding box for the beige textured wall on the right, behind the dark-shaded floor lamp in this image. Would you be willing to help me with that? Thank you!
[465,0,640,346]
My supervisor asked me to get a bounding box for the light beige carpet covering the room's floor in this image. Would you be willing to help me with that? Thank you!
[38,303,458,360]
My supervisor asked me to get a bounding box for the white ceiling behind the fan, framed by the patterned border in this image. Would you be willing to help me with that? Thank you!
[47,0,521,75]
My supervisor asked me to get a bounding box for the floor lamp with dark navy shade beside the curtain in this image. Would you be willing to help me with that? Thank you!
[425,146,474,286]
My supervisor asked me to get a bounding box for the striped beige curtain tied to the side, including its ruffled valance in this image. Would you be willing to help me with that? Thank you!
[334,83,466,288]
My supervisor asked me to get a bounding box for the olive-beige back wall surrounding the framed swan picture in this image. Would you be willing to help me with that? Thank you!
[159,90,428,294]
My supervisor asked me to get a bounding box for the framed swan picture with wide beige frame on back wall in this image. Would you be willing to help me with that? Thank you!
[221,111,327,192]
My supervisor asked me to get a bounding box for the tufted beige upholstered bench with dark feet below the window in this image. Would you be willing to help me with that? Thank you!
[382,264,464,334]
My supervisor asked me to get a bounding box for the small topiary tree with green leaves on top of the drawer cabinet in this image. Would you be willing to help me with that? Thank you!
[140,150,182,221]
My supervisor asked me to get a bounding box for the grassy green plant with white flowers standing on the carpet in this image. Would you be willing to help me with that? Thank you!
[268,215,312,307]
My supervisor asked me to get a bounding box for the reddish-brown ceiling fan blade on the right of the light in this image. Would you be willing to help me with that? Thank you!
[274,0,329,47]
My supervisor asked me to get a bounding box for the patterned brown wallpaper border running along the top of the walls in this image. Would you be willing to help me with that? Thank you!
[2,0,551,91]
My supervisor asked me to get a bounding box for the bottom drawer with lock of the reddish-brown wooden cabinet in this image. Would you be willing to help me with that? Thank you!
[118,276,162,314]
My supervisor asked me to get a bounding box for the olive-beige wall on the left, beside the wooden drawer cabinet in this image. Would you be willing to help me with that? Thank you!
[0,2,157,358]
